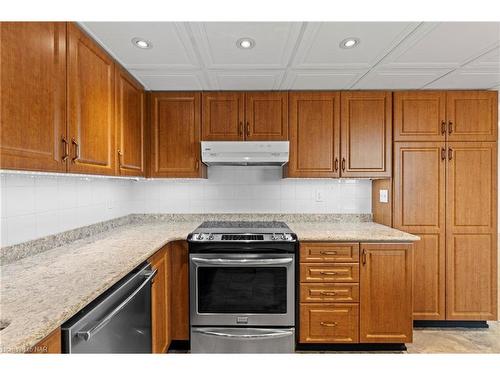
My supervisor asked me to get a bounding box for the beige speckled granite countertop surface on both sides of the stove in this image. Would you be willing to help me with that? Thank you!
[0,216,419,353]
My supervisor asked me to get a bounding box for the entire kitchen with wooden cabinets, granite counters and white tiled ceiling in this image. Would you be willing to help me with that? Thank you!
[0,0,500,374]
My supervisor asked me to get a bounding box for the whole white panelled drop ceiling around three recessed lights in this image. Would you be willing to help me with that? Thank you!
[80,22,500,90]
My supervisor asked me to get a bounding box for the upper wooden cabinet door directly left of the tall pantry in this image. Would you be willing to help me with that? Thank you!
[340,91,392,177]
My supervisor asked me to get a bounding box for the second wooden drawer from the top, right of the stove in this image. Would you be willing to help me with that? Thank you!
[300,263,359,283]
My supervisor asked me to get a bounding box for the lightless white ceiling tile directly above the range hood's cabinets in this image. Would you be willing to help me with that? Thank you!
[208,70,284,90]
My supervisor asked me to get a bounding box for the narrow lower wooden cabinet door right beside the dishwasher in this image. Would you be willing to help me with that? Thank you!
[150,248,170,353]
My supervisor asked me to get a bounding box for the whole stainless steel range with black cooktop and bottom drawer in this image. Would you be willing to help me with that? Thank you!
[188,221,297,353]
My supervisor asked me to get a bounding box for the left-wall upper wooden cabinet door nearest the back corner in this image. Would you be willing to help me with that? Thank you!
[115,67,146,176]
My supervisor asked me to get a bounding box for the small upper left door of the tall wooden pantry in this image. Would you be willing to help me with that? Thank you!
[394,91,446,142]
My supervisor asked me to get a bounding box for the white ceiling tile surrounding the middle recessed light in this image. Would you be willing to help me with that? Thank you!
[189,22,302,69]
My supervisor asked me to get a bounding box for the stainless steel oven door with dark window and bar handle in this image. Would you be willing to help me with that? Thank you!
[189,253,295,326]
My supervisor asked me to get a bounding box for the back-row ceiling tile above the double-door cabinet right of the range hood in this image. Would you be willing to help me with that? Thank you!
[281,70,366,90]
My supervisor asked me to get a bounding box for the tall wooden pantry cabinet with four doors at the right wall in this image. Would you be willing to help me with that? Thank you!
[393,91,498,320]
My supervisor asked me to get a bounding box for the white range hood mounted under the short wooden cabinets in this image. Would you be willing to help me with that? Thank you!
[201,141,289,166]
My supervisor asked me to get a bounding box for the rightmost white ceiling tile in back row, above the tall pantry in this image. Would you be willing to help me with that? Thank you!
[425,69,500,90]
